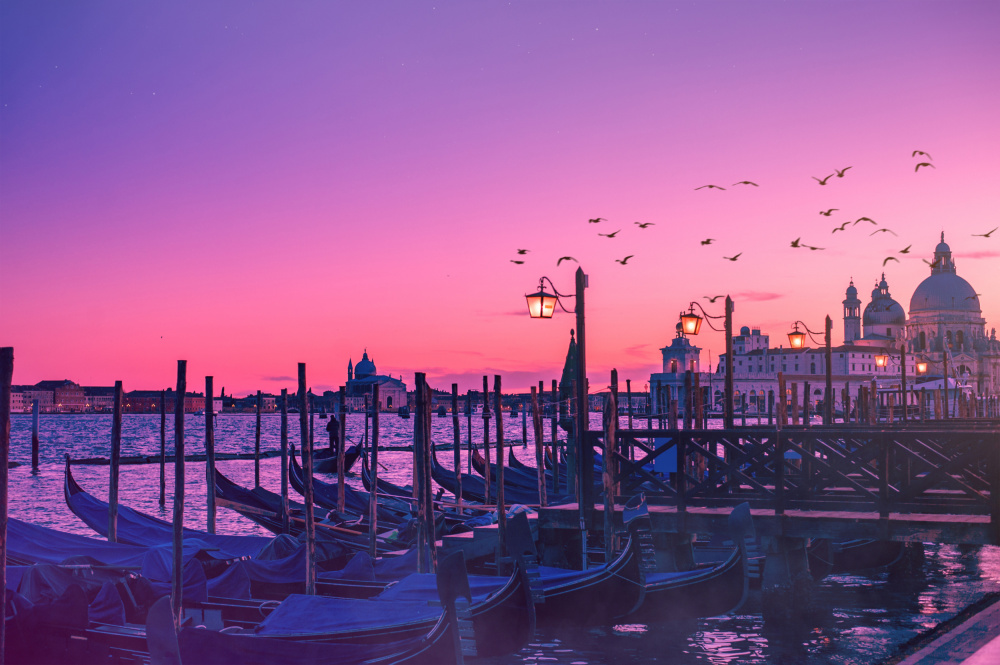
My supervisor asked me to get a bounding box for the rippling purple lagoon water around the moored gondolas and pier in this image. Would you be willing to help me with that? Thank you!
[10,414,1000,665]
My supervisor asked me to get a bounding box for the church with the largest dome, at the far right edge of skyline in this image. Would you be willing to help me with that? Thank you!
[905,233,1000,394]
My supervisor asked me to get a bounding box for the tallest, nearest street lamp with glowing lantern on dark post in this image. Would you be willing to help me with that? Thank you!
[525,268,594,526]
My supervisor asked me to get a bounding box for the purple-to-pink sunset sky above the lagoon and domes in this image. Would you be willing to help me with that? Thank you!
[0,0,1000,395]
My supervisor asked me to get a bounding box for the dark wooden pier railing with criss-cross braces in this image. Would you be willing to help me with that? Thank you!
[592,428,1000,525]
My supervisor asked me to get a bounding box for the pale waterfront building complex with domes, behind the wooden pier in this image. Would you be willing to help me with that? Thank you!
[650,233,1000,413]
